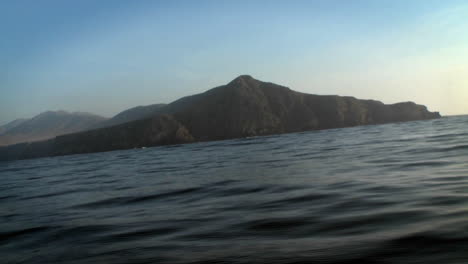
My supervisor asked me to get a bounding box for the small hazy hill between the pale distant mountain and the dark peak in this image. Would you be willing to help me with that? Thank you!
[95,104,166,128]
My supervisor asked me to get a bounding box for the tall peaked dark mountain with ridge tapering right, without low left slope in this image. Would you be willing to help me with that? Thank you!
[163,75,440,140]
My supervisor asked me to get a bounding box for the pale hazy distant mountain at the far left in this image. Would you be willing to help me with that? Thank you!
[0,111,106,145]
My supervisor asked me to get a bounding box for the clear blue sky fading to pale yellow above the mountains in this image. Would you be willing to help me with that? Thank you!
[0,0,468,124]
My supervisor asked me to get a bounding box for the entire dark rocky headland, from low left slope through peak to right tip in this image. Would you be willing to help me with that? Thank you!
[0,75,440,160]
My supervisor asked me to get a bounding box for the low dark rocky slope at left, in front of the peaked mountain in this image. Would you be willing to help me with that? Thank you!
[0,115,195,160]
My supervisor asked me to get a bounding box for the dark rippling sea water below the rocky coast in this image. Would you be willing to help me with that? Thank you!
[0,116,468,264]
